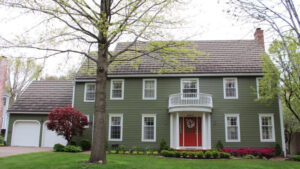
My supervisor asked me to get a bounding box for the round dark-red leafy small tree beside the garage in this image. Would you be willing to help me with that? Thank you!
[46,105,88,143]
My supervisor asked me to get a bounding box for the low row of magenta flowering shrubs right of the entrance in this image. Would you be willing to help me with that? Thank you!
[219,147,276,158]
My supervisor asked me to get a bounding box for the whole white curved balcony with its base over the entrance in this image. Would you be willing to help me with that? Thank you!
[169,93,213,112]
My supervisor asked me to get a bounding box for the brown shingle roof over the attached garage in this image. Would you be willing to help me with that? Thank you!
[8,80,73,113]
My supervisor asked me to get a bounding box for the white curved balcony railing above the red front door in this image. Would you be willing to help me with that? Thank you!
[169,93,213,108]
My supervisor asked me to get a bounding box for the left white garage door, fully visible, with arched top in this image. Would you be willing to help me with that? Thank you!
[11,121,40,147]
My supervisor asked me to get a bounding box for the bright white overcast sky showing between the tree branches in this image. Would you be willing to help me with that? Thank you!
[0,0,272,76]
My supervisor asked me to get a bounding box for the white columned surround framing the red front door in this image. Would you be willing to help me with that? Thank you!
[170,112,211,150]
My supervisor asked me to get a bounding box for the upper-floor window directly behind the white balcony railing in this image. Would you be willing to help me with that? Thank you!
[181,79,199,98]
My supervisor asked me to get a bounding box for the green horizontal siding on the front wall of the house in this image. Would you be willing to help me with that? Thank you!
[75,77,281,148]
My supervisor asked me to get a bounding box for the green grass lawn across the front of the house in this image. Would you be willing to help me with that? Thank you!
[0,152,300,169]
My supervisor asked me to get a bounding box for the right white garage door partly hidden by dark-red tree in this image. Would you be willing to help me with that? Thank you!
[42,123,67,147]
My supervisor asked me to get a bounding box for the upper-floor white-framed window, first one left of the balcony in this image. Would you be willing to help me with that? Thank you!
[143,79,156,100]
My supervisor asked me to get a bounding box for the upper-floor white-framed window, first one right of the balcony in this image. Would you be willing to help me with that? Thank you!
[223,78,238,99]
